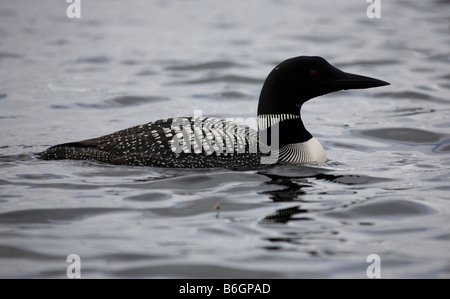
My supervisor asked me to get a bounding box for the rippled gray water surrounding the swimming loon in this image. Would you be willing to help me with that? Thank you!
[0,0,450,278]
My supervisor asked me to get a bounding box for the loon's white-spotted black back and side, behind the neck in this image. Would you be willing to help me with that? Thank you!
[41,117,259,168]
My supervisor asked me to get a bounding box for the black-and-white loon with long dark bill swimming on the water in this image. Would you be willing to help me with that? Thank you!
[39,56,389,168]
